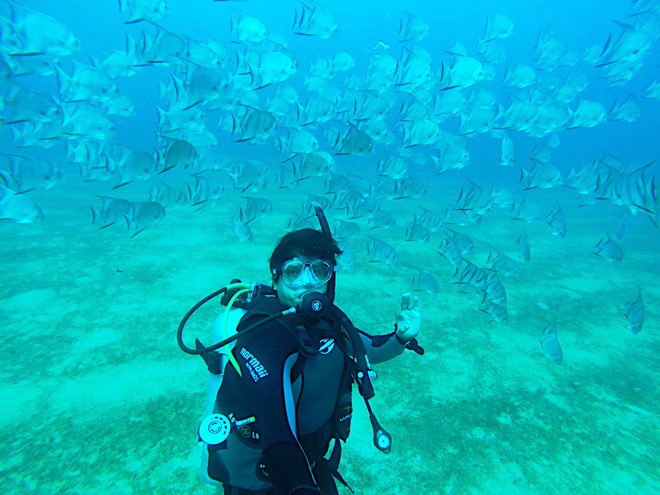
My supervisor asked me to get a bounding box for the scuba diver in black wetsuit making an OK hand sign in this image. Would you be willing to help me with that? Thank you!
[178,205,423,495]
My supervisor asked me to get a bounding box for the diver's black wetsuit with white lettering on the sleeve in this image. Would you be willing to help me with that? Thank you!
[208,297,405,495]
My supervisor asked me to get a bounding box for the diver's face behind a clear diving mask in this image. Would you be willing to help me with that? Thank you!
[273,258,333,307]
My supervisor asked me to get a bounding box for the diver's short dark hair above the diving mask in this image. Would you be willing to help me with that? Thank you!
[270,229,342,280]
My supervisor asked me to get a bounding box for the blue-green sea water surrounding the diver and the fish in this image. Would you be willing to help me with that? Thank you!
[0,0,660,495]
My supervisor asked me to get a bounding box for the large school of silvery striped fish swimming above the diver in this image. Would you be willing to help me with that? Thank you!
[0,0,660,356]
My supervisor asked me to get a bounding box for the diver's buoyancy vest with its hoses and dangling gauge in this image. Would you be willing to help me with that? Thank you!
[177,280,391,489]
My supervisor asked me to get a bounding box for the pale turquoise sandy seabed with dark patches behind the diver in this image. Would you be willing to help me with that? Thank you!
[0,169,660,495]
